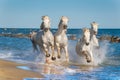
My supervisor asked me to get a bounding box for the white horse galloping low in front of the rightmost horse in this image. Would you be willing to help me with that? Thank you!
[76,28,93,63]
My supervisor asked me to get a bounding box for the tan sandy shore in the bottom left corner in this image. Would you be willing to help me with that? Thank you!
[0,59,43,80]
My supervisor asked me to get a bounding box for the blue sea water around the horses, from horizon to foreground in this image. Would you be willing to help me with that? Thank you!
[0,28,120,80]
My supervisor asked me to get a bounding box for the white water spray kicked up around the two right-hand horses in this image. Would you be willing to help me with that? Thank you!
[68,41,109,66]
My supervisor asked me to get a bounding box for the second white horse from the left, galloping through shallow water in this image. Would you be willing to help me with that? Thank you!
[54,16,69,62]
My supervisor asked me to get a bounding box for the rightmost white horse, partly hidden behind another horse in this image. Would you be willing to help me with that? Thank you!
[90,22,99,47]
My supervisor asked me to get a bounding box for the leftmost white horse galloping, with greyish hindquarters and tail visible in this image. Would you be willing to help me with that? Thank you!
[31,16,56,60]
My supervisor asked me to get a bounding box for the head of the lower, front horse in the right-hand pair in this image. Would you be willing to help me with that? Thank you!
[83,28,90,46]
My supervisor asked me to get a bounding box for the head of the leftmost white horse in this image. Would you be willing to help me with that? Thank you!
[40,16,50,32]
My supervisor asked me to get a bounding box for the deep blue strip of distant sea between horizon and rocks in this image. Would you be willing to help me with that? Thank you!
[0,28,120,36]
